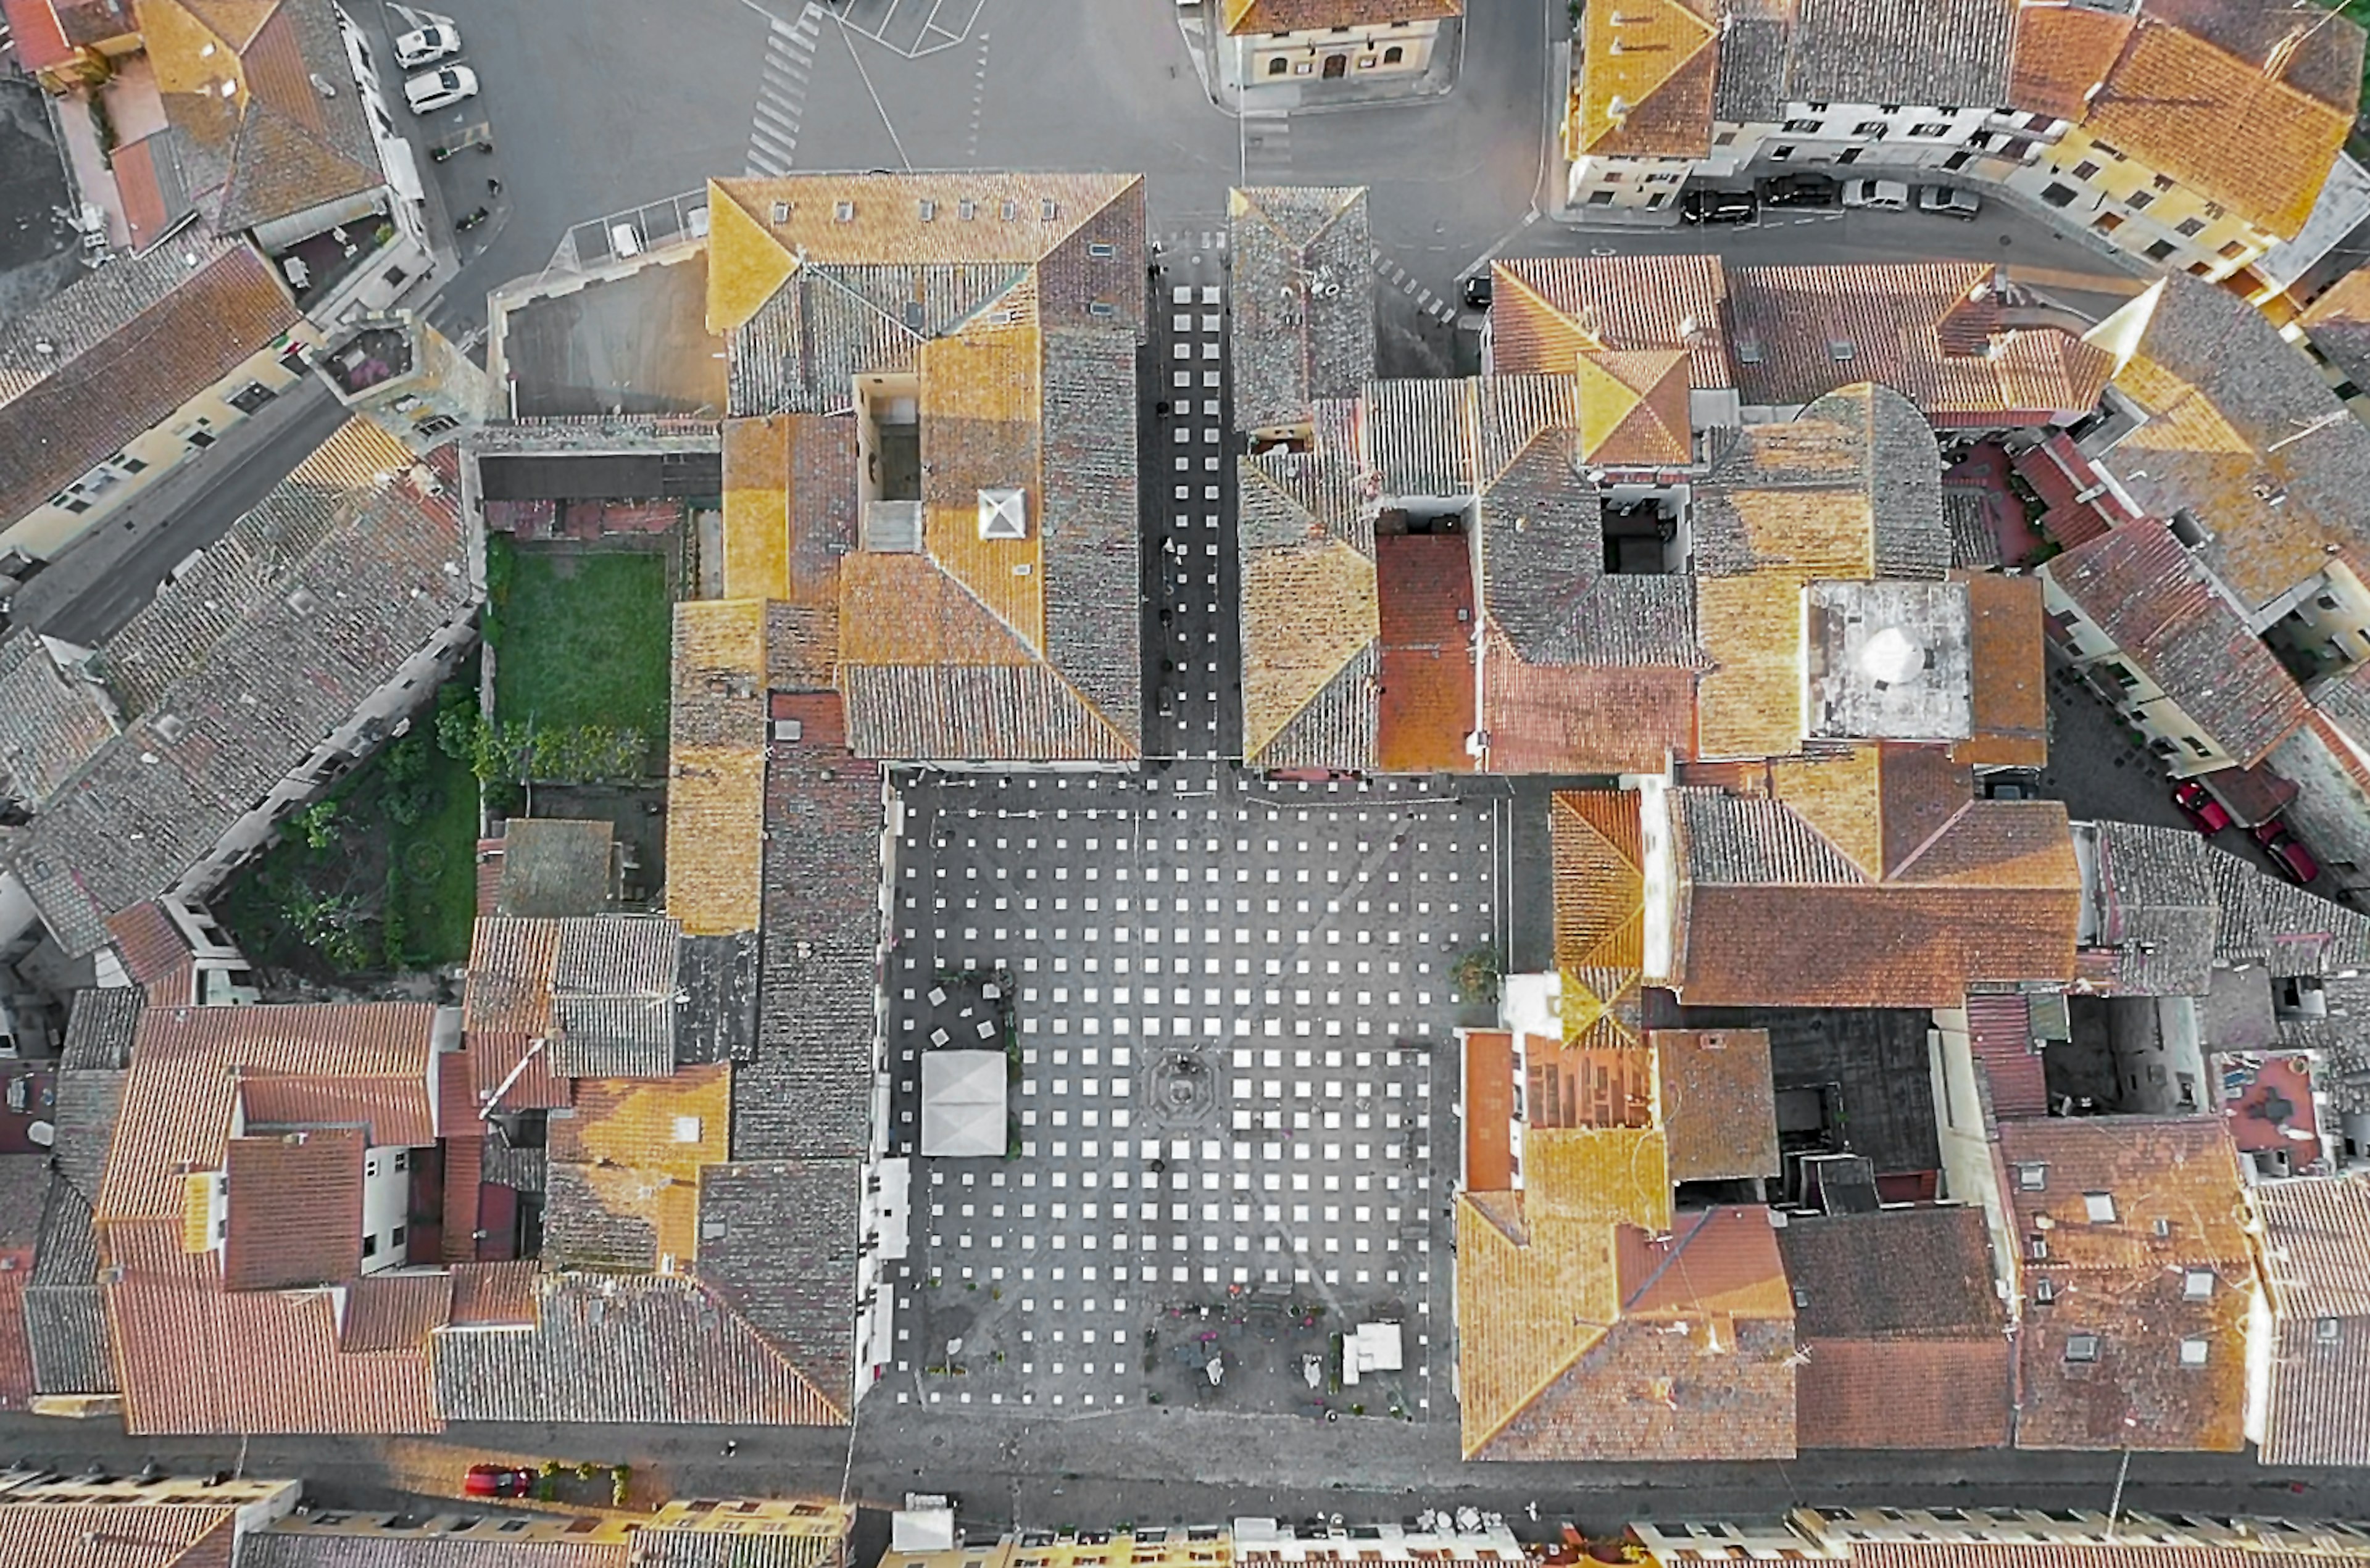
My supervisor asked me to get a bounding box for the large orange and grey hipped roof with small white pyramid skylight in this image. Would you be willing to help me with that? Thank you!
[709,175,1145,760]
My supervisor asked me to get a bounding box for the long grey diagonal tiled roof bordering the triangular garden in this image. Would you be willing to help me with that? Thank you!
[9,419,476,957]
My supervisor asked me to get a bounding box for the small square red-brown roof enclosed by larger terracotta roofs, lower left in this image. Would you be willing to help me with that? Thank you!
[223,1127,370,1291]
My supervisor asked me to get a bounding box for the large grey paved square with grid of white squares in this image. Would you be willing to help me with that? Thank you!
[886,765,1505,1421]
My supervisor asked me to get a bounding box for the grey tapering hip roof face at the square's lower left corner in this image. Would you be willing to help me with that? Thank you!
[697,1158,865,1404]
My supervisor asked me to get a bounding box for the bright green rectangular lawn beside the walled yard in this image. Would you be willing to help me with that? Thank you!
[486,533,673,758]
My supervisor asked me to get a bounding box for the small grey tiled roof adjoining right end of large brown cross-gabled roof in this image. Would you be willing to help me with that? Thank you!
[2095,822,2221,997]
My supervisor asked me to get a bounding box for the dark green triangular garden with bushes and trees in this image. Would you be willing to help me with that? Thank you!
[214,661,479,983]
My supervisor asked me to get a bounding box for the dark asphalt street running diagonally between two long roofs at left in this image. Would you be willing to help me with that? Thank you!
[9,376,346,647]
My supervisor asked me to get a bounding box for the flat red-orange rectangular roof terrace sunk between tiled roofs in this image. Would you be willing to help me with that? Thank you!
[1374,533,1474,772]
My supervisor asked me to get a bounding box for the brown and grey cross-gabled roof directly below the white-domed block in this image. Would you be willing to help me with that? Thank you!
[1673,749,2081,1006]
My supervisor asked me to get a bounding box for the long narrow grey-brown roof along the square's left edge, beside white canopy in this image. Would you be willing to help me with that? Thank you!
[733,727,881,1161]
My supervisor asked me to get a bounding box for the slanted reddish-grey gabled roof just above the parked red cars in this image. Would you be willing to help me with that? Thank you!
[2040,519,2306,768]
